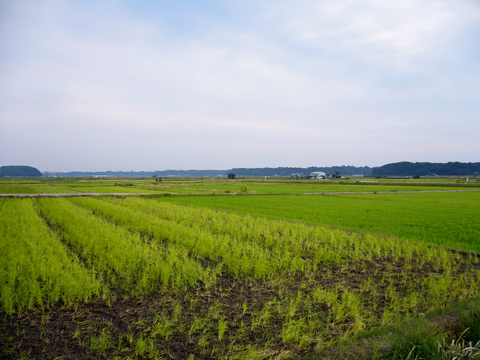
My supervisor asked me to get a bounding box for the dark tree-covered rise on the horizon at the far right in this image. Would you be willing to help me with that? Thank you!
[372,161,480,176]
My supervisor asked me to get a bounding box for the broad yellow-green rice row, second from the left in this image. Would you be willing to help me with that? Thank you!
[38,199,214,294]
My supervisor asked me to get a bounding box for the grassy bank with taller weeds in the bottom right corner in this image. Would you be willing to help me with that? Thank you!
[334,296,480,360]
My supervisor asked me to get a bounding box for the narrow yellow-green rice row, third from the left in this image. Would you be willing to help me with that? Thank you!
[70,198,305,278]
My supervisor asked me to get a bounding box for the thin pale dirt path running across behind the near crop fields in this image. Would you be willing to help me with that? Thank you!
[0,190,480,198]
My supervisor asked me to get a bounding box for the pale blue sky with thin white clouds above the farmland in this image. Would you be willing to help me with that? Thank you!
[0,0,480,172]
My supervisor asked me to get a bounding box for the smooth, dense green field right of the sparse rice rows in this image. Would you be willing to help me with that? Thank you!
[159,193,480,252]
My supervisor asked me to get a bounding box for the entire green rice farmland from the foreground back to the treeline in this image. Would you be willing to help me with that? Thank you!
[0,179,480,359]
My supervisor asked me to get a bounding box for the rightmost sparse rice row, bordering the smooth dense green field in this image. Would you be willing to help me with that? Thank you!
[107,198,468,269]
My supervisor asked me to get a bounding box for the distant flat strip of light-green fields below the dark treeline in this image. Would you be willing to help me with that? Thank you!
[0,178,480,194]
